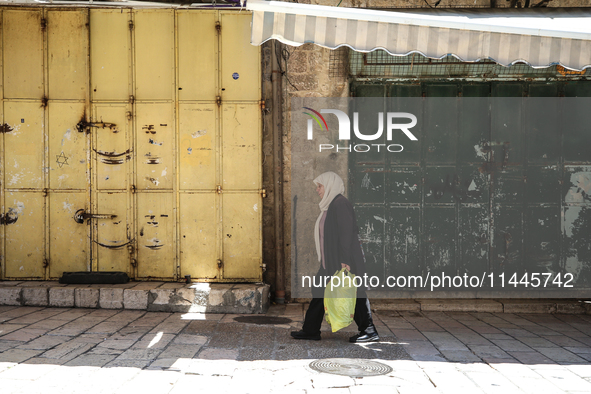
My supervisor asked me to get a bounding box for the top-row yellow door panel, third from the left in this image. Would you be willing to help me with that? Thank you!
[90,8,132,101]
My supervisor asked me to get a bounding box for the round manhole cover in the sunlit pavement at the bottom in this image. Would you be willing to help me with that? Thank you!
[310,358,392,377]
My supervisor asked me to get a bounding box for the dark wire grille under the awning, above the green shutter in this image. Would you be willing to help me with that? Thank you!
[349,50,591,79]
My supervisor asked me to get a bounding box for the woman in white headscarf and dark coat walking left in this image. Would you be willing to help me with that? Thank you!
[291,172,379,343]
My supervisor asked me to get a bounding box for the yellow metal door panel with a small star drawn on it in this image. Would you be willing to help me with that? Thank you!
[47,101,90,190]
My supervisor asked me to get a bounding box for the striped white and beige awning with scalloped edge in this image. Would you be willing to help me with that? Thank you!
[246,0,591,70]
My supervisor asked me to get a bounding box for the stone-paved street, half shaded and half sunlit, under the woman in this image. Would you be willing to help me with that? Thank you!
[0,304,591,394]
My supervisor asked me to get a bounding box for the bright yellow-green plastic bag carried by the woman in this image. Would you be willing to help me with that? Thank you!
[324,268,357,332]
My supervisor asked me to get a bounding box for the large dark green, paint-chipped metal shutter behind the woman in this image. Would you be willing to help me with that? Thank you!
[349,82,591,292]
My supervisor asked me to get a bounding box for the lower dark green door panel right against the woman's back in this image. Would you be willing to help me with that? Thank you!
[355,204,391,276]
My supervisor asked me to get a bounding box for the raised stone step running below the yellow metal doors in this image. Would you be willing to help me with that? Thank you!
[0,281,270,314]
